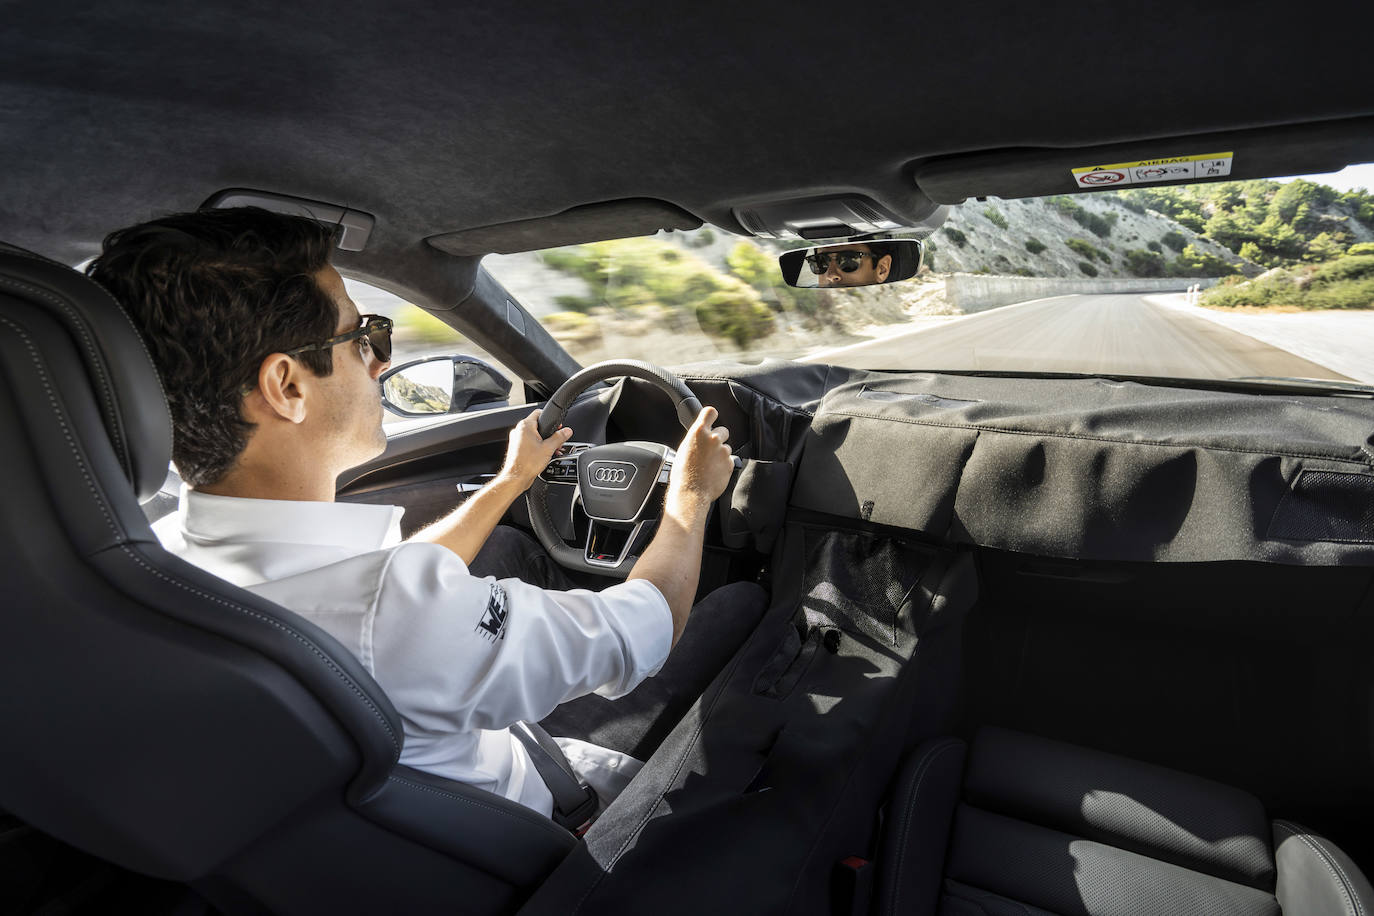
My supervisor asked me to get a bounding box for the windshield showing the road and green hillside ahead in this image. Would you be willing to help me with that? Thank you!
[482,173,1374,385]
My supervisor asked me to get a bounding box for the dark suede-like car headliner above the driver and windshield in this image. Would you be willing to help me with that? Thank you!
[0,0,1374,275]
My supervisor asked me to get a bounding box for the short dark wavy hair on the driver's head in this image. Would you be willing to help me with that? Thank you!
[87,207,338,486]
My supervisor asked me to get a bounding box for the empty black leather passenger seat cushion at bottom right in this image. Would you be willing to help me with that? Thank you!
[875,728,1374,916]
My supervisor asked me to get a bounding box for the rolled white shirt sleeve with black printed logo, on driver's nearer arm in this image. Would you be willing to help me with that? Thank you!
[371,544,673,731]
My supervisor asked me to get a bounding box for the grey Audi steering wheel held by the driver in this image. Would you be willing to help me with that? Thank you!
[525,360,701,578]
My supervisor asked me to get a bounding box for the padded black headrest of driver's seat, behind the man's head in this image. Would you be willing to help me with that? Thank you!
[0,243,172,503]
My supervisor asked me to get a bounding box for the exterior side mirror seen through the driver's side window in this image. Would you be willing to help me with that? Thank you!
[378,356,511,416]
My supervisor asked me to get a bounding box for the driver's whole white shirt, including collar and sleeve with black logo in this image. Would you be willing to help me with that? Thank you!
[154,486,672,814]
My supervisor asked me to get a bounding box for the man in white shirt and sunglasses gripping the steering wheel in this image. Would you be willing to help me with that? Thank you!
[88,207,763,829]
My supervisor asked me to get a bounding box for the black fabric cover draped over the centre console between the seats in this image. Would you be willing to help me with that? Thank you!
[522,525,976,916]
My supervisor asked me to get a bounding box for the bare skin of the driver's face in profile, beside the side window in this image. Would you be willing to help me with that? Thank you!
[312,266,389,467]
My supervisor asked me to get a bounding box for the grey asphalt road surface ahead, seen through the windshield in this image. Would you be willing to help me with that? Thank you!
[804,294,1348,380]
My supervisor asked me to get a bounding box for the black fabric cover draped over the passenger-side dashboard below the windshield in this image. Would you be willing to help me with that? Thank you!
[774,367,1374,566]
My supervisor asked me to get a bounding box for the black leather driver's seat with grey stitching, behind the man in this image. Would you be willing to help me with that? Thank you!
[0,246,578,913]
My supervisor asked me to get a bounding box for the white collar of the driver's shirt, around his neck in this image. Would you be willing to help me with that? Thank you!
[177,483,405,552]
